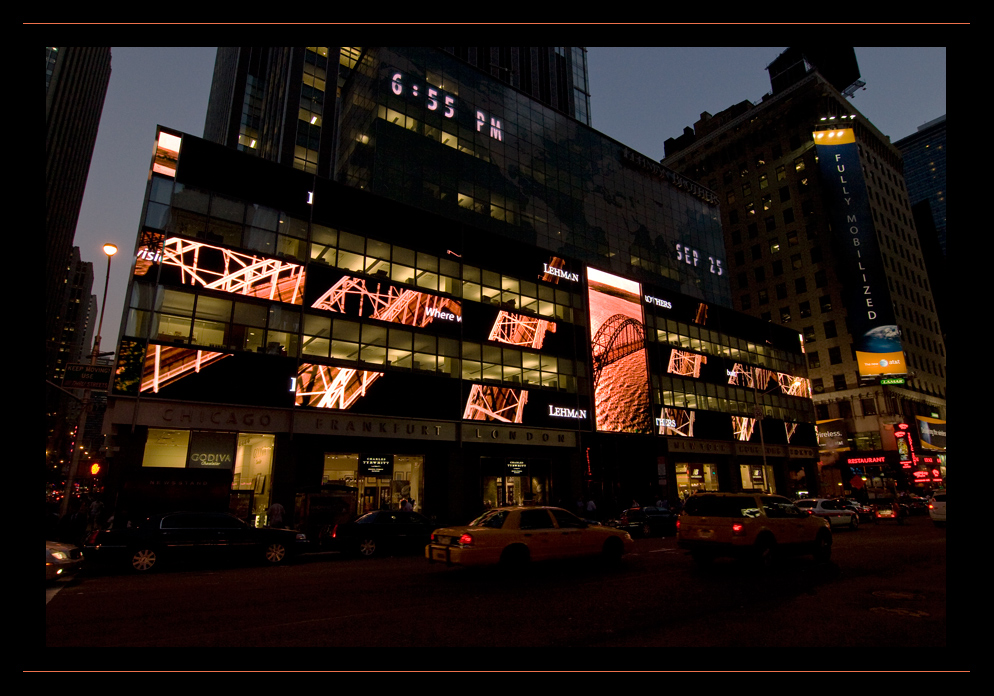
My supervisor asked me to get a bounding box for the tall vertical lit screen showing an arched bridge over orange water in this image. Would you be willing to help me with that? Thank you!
[587,268,654,433]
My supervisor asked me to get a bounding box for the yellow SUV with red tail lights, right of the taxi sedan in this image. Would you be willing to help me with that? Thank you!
[677,493,832,566]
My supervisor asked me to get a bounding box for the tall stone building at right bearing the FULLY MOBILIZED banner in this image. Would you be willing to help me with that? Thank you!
[663,49,946,495]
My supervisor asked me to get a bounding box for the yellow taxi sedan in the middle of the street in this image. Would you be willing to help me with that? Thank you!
[425,506,635,567]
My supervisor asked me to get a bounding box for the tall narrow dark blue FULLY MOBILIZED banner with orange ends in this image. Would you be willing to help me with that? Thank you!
[813,129,907,377]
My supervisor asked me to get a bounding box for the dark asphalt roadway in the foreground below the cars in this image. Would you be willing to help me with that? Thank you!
[46,517,946,669]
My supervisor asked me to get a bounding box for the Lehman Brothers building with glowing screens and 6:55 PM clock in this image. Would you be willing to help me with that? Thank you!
[105,49,816,531]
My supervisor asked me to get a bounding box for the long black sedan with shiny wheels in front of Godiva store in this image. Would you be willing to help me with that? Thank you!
[83,512,307,573]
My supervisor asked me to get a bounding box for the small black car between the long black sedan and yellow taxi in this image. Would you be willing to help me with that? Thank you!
[331,510,435,558]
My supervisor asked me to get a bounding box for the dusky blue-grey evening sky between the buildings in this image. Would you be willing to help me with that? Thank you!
[74,46,946,338]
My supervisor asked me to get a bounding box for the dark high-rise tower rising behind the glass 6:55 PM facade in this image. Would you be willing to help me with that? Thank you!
[204,46,590,177]
